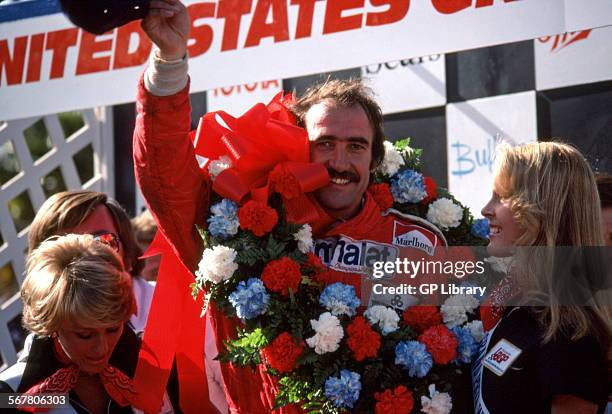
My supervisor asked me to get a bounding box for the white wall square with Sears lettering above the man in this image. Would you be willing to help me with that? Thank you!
[361,55,446,114]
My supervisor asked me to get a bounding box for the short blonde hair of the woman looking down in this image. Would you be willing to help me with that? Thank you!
[21,234,136,335]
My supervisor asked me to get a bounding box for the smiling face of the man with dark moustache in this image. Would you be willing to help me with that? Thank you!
[305,100,374,220]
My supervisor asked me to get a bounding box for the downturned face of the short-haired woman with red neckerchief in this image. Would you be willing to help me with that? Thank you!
[57,321,123,375]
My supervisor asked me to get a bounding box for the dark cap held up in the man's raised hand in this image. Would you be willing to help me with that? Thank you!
[60,0,149,34]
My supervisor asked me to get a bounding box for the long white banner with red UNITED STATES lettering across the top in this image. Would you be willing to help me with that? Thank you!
[0,0,612,120]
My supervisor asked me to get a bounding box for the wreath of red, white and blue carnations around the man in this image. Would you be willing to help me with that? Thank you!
[193,97,502,413]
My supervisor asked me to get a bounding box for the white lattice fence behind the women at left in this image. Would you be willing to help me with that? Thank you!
[0,107,114,371]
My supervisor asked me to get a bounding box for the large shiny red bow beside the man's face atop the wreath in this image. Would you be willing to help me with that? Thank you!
[194,94,329,224]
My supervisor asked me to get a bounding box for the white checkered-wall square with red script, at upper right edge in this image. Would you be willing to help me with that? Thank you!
[534,25,612,90]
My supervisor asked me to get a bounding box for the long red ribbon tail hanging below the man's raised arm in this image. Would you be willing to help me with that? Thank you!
[134,231,214,413]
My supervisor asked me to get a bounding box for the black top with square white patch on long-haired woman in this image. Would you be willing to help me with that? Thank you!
[473,307,610,414]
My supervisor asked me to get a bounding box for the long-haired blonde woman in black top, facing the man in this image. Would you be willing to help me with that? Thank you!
[473,142,612,414]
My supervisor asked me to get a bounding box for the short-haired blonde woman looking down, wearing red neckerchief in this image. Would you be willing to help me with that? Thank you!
[0,234,173,414]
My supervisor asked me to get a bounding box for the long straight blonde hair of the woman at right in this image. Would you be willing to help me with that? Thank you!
[494,142,612,346]
